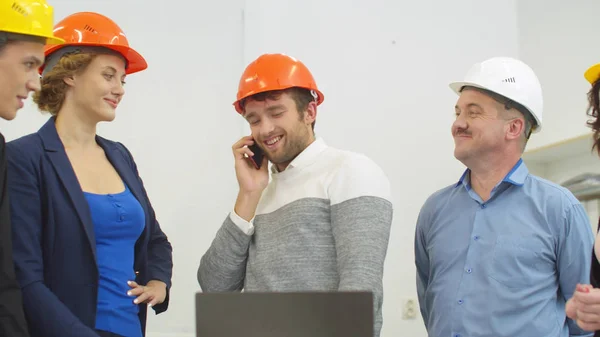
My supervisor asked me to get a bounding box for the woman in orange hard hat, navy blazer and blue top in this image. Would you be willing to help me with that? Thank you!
[7,12,173,337]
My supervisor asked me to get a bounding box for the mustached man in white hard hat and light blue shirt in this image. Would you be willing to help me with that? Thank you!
[415,57,594,337]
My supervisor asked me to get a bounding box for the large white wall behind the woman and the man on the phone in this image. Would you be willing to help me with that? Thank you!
[0,0,528,337]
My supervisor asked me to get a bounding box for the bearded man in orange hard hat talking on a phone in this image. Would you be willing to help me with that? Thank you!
[198,54,393,336]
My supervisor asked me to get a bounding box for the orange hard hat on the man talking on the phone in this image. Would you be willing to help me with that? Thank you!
[233,54,325,114]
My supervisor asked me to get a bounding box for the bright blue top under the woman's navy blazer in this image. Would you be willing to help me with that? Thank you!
[84,185,145,337]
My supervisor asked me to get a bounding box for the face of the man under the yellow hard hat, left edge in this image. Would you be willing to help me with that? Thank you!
[0,41,44,120]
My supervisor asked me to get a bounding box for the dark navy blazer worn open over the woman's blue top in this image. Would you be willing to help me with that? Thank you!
[6,117,173,337]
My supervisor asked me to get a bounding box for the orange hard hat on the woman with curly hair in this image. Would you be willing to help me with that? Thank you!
[40,12,148,74]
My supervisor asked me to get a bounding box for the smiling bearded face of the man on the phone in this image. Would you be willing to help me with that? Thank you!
[244,91,316,171]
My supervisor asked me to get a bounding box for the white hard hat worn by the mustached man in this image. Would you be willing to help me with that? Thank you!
[450,57,544,132]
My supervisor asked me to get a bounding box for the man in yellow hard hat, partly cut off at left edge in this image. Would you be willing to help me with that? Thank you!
[0,0,64,337]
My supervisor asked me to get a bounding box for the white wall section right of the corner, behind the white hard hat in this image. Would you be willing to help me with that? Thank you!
[517,0,600,149]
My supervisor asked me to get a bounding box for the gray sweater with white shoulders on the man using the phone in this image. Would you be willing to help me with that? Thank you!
[198,139,393,337]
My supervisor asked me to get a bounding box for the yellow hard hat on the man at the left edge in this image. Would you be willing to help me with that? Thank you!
[0,0,65,44]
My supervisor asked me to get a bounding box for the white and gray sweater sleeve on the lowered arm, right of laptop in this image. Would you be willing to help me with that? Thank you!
[329,156,393,337]
